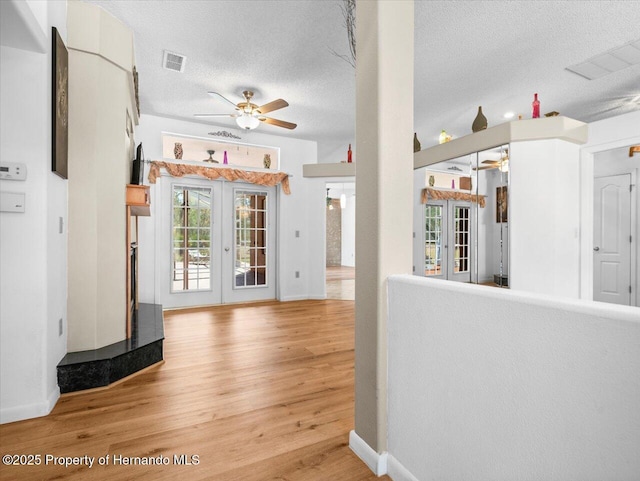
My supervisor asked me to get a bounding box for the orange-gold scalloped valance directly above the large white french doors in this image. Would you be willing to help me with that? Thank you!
[149,160,291,195]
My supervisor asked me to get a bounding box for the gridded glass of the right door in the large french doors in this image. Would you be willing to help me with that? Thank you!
[234,191,267,288]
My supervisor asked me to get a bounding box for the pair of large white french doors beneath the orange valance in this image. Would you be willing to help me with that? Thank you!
[159,179,277,308]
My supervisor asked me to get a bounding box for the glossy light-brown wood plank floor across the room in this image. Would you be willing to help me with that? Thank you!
[0,300,390,481]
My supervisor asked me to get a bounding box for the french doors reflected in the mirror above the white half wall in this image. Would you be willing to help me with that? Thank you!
[424,200,473,282]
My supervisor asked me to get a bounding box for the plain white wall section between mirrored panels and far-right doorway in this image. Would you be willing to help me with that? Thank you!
[509,139,580,299]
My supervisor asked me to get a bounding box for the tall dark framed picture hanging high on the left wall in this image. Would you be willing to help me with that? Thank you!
[51,27,69,179]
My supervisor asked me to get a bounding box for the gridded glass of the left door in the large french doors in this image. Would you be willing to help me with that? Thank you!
[171,185,211,292]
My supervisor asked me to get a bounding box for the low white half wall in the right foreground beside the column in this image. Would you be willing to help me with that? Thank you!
[388,276,640,481]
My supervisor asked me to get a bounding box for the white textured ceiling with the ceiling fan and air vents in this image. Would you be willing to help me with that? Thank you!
[90,0,640,162]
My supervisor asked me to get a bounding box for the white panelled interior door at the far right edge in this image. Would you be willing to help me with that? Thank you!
[593,174,631,305]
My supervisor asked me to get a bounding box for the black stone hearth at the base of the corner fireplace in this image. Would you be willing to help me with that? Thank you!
[58,303,164,393]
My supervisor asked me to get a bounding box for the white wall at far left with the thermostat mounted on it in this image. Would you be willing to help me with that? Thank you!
[0,1,67,423]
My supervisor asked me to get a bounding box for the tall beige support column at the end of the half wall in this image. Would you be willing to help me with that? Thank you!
[355,0,414,453]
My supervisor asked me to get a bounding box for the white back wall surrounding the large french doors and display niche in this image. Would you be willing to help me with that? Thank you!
[136,115,325,303]
